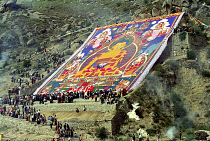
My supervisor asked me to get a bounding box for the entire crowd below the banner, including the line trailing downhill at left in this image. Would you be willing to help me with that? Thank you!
[0,90,122,140]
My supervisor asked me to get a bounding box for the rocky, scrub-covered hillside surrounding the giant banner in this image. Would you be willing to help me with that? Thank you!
[0,0,210,141]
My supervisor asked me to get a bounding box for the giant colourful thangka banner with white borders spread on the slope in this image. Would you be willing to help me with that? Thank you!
[34,13,183,94]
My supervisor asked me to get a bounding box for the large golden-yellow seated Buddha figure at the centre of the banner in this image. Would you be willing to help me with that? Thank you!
[74,42,127,78]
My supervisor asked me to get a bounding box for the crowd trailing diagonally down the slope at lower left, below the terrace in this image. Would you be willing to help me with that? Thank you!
[0,96,83,140]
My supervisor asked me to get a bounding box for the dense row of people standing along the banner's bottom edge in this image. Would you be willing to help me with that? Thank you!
[0,90,126,106]
